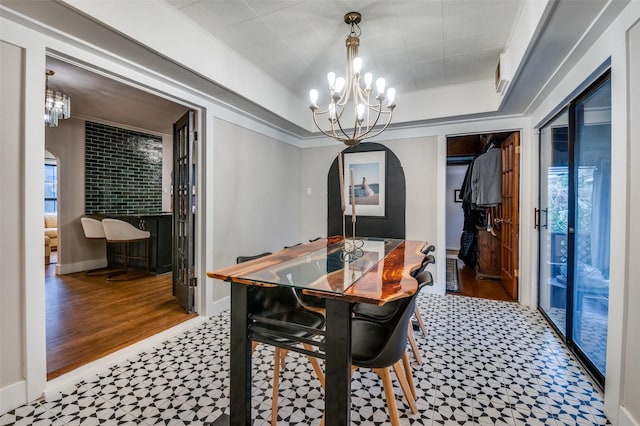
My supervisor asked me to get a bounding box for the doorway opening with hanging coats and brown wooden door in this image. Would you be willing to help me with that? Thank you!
[446,131,520,301]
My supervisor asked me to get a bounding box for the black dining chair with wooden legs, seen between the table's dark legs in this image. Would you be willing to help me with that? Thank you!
[236,253,325,425]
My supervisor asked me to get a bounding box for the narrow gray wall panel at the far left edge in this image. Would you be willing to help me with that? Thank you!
[0,42,25,389]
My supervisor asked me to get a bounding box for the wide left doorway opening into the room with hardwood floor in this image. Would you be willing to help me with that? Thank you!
[45,57,198,380]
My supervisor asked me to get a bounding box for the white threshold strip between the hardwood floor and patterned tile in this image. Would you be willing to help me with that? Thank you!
[43,316,207,400]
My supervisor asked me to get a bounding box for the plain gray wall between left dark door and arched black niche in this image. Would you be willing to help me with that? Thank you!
[212,118,301,272]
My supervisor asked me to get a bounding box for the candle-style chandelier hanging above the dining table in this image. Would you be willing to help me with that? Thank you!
[309,12,396,146]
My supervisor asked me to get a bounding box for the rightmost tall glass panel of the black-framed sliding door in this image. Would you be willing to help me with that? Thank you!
[572,77,611,375]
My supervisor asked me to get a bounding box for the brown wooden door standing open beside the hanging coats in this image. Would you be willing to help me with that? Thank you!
[500,132,520,299]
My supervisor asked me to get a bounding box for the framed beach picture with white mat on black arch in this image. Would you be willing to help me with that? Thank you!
[343,151,386,216]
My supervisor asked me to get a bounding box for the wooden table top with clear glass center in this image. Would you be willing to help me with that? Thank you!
[207,236,425,305]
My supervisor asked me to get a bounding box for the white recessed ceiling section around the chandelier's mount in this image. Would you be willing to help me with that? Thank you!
[166,0,523,96]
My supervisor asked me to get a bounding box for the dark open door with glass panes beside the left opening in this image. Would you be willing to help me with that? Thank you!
[173,111,196,312]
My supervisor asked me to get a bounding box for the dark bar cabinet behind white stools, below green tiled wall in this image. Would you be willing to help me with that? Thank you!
[107,214,173,274]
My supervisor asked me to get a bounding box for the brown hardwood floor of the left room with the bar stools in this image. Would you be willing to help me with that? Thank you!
[45,251,196,380]
